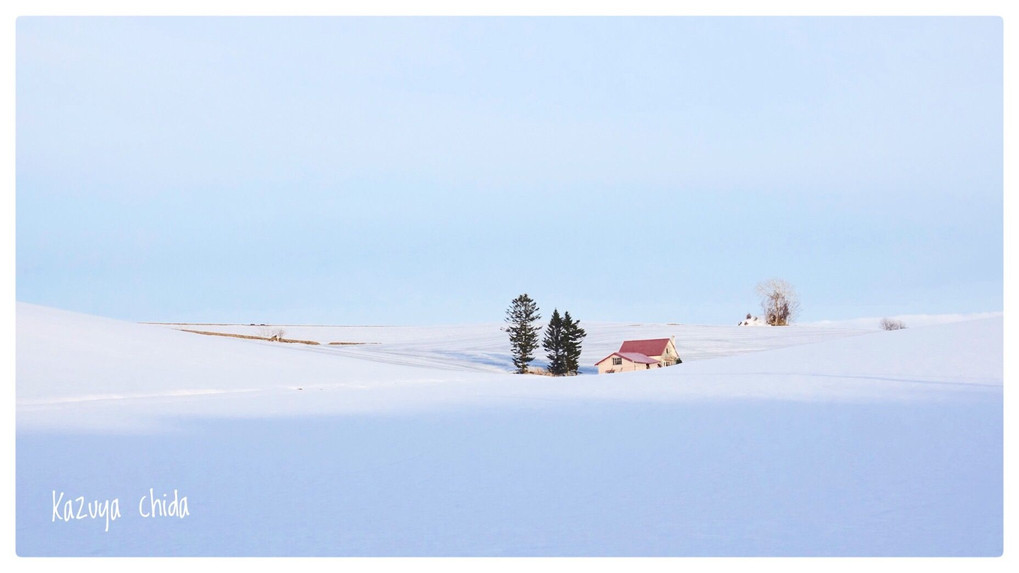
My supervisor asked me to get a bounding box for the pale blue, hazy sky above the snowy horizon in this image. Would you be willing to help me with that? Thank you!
[16,17,1003,324]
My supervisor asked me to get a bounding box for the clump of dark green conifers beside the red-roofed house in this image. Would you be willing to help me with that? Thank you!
[505,294,587,376]
